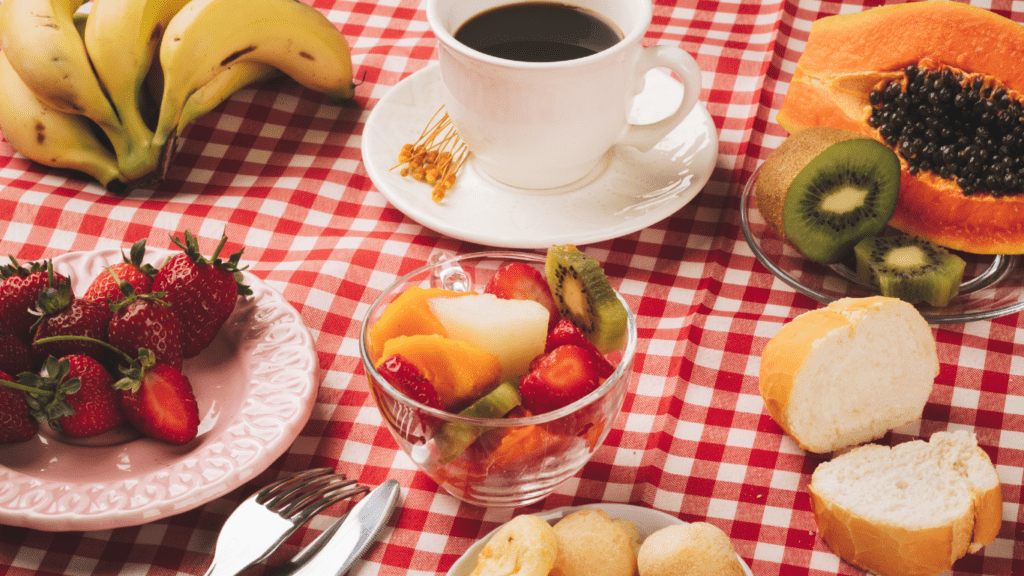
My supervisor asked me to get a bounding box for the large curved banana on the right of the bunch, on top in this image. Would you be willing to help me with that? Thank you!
[153,0,353,156]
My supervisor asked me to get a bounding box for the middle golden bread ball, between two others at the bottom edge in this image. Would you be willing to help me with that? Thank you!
[550,508,639,576]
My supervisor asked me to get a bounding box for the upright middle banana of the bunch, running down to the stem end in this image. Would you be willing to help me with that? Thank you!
[83,0,188,178]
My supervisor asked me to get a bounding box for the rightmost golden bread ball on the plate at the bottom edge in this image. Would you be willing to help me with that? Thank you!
[637,522,745,576]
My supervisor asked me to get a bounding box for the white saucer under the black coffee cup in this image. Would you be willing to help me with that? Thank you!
[362,64,718,248]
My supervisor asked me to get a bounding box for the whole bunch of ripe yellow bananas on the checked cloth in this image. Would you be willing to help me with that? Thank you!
[0,0,353,193]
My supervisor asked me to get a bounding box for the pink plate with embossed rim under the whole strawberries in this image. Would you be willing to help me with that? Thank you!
[0,248,318,531]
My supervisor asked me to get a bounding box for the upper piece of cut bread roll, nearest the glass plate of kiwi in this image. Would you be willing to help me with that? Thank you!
[760,296,939,453]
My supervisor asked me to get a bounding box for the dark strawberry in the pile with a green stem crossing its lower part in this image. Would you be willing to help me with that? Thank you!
[32,271,111,364]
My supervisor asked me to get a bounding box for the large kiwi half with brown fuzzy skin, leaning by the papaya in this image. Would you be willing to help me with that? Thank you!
[755,127,900,264]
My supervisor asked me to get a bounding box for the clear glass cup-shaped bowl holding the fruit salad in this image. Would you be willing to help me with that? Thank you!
[359,251,637,506]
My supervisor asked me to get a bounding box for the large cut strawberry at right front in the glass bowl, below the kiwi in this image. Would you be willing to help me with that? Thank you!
[519,344,601,414]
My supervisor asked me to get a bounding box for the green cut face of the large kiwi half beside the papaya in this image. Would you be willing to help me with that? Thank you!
[782,138,900,264]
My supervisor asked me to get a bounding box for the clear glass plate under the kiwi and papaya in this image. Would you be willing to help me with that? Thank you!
[739,166,1024,324]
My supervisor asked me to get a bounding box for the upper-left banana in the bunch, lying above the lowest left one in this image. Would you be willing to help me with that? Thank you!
[0,0,130,168]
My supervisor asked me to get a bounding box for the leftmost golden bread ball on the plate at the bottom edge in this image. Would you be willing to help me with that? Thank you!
[471,515,558,576]
